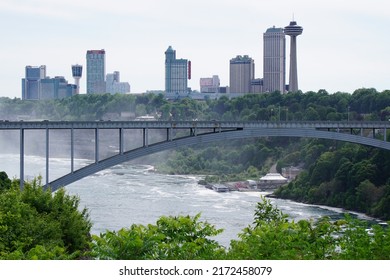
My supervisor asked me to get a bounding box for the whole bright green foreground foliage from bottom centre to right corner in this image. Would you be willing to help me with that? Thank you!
[89,199,390,260]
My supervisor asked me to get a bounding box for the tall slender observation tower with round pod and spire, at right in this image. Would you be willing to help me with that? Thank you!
[284,21,303,92]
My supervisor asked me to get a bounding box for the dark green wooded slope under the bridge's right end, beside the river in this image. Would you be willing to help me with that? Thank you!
[275,140,390,220]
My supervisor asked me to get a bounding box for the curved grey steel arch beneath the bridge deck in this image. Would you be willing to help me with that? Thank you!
[48,128,390,192]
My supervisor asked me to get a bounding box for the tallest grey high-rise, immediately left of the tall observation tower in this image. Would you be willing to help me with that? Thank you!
[263,26,286,93]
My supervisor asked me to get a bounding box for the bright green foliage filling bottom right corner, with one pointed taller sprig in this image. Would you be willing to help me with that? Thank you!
[227,199,390,260]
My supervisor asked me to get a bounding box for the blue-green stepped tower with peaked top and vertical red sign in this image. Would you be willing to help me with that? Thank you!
[165,46,191,94]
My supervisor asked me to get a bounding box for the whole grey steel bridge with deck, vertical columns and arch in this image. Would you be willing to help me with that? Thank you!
[0,121,390,191]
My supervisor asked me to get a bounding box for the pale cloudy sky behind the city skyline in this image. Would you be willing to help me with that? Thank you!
[0,0,390,98]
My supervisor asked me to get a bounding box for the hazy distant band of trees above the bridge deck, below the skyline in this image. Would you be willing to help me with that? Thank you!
[0,89,390,121]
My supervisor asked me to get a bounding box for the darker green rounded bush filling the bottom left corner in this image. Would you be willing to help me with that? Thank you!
[0,172,92,259]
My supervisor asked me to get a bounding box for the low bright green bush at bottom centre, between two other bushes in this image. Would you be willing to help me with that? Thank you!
[92,214,224,260]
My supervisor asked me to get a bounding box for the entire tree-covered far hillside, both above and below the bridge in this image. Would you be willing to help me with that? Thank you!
[0,89,390,219]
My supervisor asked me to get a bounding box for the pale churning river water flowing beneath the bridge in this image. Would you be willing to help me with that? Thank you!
[0,154,378,246]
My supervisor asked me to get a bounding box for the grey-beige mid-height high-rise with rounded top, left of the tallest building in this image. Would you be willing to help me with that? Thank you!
[230,55,255,93]
